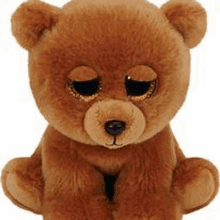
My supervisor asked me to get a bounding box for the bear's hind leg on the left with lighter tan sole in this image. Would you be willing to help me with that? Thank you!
[1,155,43,214]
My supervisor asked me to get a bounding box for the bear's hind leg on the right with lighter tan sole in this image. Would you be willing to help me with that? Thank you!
[173,158,219,214]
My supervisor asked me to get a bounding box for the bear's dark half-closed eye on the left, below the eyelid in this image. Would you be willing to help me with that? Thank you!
[69,78,100,96]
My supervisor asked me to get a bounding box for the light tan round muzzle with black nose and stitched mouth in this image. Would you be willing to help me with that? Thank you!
[84,99,146,149]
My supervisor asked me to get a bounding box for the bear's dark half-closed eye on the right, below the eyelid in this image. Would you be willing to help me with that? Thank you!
[125,76,156,98]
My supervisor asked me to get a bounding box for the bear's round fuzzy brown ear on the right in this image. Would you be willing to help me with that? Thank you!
[161,0,207,48]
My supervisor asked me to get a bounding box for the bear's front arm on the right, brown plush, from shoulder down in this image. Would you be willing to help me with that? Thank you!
[114,126,184,220]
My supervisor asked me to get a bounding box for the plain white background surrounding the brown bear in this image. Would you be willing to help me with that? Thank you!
[0,0,220,220]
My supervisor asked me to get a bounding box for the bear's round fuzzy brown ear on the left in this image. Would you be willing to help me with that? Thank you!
[11,0,61,50]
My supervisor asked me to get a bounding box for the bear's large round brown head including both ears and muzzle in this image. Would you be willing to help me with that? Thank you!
[12,0,206,149]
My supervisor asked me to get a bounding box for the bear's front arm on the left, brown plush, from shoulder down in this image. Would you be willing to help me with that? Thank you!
[42,125,110,220]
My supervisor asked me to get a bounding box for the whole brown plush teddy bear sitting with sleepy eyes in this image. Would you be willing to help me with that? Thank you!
[2,0,219,220]
